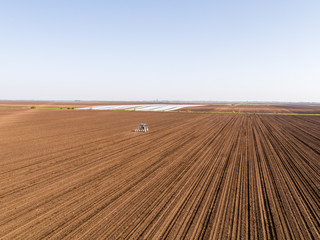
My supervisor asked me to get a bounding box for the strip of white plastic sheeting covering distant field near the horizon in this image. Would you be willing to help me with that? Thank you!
[78,104,203,112]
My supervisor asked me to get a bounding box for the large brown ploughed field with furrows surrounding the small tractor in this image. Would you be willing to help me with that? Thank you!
[0,109,320,239]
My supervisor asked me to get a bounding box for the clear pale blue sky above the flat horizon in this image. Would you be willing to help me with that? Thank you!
[0,0,320,102]
